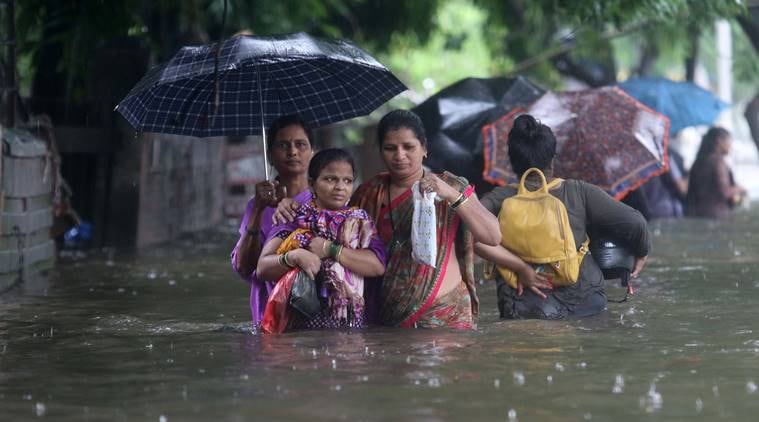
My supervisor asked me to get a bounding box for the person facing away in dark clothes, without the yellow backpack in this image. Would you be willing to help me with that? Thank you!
[475,114,651,319]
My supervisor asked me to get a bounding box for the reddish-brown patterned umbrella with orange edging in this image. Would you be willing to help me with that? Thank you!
[482,87,669,199]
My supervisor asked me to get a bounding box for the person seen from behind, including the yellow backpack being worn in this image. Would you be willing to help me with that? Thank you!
[475,114,651,319]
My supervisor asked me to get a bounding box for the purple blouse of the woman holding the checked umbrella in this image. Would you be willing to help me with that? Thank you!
[232,189,311,326]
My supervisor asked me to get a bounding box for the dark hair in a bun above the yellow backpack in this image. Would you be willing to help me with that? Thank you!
[509,114,556,176]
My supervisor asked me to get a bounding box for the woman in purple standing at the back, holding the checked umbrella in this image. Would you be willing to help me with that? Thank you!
[232,115,314,327]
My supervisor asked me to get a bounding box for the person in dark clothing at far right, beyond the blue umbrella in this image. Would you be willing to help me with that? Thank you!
[685,127,746,218]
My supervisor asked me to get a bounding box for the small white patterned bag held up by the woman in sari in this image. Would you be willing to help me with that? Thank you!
[411,182,437,267]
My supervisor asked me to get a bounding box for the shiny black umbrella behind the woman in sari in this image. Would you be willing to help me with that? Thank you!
[414,76,545,192]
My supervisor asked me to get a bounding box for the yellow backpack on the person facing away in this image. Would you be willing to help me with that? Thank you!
[497,168,588,288]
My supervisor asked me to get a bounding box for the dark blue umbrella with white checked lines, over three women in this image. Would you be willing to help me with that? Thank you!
[116,33,406,178]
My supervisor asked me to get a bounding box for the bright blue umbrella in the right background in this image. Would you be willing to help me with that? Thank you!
[619,78,728,135]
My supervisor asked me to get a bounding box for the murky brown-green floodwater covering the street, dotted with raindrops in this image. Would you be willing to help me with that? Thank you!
[0,207,759,421]
